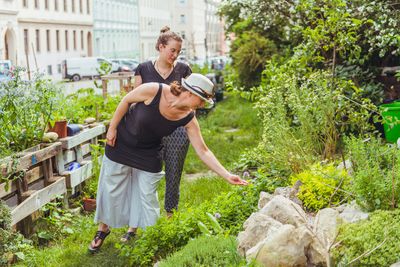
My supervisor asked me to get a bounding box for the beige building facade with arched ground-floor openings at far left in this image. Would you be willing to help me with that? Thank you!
[0,0,93,79]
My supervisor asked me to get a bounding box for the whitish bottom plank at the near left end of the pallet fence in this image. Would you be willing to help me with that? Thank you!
[11,177,67,225]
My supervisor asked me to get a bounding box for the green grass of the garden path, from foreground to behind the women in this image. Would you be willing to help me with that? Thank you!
[17,95,260,266]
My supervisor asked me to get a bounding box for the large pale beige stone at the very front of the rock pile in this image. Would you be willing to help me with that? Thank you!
[246,224,312,267]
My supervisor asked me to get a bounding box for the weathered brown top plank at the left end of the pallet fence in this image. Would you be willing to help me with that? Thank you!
[0,142,61,176]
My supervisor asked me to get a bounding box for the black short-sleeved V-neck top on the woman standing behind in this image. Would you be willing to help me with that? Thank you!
[135,61,192,84]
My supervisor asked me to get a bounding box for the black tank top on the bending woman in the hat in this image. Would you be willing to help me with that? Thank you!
[105,84,194,173]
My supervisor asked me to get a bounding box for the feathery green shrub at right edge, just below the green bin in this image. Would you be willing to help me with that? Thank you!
[345,137,400,211]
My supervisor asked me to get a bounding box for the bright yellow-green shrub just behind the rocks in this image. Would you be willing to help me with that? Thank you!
[291,164,350,211]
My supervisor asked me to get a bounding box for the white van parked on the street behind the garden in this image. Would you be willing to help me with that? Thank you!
[61,57,115,82]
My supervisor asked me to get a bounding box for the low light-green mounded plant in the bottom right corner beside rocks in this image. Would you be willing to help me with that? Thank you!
[332,210,400,266]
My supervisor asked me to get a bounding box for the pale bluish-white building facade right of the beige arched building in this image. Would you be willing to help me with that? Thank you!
[93,0,140,60]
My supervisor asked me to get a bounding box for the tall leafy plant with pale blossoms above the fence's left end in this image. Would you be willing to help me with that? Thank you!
[0,68,60,156]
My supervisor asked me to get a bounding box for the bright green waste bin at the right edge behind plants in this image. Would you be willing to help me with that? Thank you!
[379,101,400,143]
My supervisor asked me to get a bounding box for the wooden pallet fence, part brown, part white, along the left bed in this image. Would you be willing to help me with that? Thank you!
[0,124,106,234]
